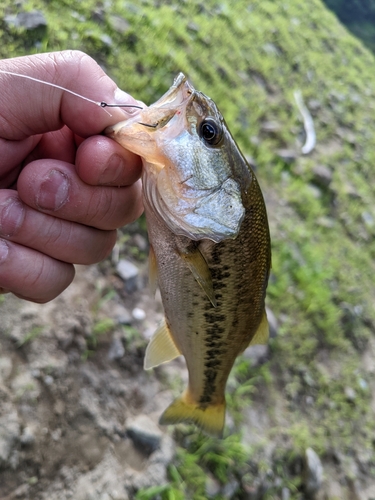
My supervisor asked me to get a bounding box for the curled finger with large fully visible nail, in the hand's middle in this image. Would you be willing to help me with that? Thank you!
[17,160,143,230]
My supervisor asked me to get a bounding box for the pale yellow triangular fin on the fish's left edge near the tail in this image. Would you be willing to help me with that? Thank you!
[144,320,181,370]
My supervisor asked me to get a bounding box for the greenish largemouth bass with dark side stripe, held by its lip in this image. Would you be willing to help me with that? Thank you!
[105,73,271,438]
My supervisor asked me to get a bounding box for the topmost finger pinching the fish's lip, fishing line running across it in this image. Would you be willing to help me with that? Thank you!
[0,51,142,140]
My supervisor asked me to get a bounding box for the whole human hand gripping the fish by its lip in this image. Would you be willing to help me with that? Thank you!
[0,51,142,303]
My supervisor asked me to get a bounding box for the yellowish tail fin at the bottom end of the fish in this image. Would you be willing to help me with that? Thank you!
[159,391,225,438]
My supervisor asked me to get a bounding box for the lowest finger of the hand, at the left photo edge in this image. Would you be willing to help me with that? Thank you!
[0,239,75,303]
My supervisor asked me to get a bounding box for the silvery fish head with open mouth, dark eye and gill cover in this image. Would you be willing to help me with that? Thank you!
[105,73,253,242]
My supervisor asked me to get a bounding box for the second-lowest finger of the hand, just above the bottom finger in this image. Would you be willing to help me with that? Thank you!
[0,189,116,264]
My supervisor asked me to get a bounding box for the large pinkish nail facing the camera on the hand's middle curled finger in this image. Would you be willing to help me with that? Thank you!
[36,169,69,211]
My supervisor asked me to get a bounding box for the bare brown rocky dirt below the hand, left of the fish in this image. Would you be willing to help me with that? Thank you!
[0,266,183,500]
